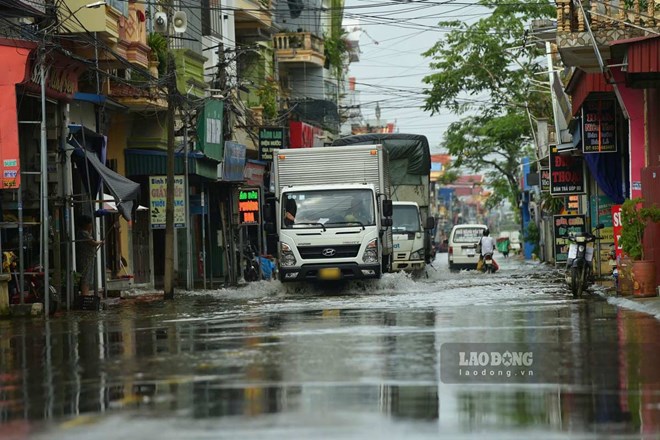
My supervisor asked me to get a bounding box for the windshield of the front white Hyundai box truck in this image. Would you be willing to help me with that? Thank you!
[281,189,376,228]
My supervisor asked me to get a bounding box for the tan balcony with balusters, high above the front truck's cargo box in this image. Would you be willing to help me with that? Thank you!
[273,32,325,67]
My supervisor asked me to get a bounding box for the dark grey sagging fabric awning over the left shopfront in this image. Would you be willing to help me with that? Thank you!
[67,125,140,221]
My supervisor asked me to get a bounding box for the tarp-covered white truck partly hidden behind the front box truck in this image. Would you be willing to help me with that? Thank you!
[333,133,435,273]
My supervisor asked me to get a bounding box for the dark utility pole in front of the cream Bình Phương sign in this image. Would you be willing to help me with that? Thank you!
[163,8,176,299]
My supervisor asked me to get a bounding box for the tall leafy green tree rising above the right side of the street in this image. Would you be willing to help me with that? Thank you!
[424,0,556,212]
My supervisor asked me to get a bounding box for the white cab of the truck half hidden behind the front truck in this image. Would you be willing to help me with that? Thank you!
[392,201,432,273]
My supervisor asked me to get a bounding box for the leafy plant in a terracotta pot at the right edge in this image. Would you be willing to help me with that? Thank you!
[619,198,660,297]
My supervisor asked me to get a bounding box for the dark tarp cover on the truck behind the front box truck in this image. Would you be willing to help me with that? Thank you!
[333,133,431,185]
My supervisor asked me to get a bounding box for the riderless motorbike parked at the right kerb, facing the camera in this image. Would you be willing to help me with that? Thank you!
[565,223,605,298]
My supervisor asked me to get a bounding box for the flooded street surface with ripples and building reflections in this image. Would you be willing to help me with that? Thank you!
[0,254,660,440]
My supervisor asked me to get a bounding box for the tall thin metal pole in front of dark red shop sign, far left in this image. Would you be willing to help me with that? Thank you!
[39,47,50,319]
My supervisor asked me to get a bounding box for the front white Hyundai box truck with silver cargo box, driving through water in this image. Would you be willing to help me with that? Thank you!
[267,145,392,282]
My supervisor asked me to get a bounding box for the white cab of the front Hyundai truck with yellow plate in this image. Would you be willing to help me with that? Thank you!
[278,184,383,282]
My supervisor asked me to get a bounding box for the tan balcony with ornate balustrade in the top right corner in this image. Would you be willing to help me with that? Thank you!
[556,0,660,72]
